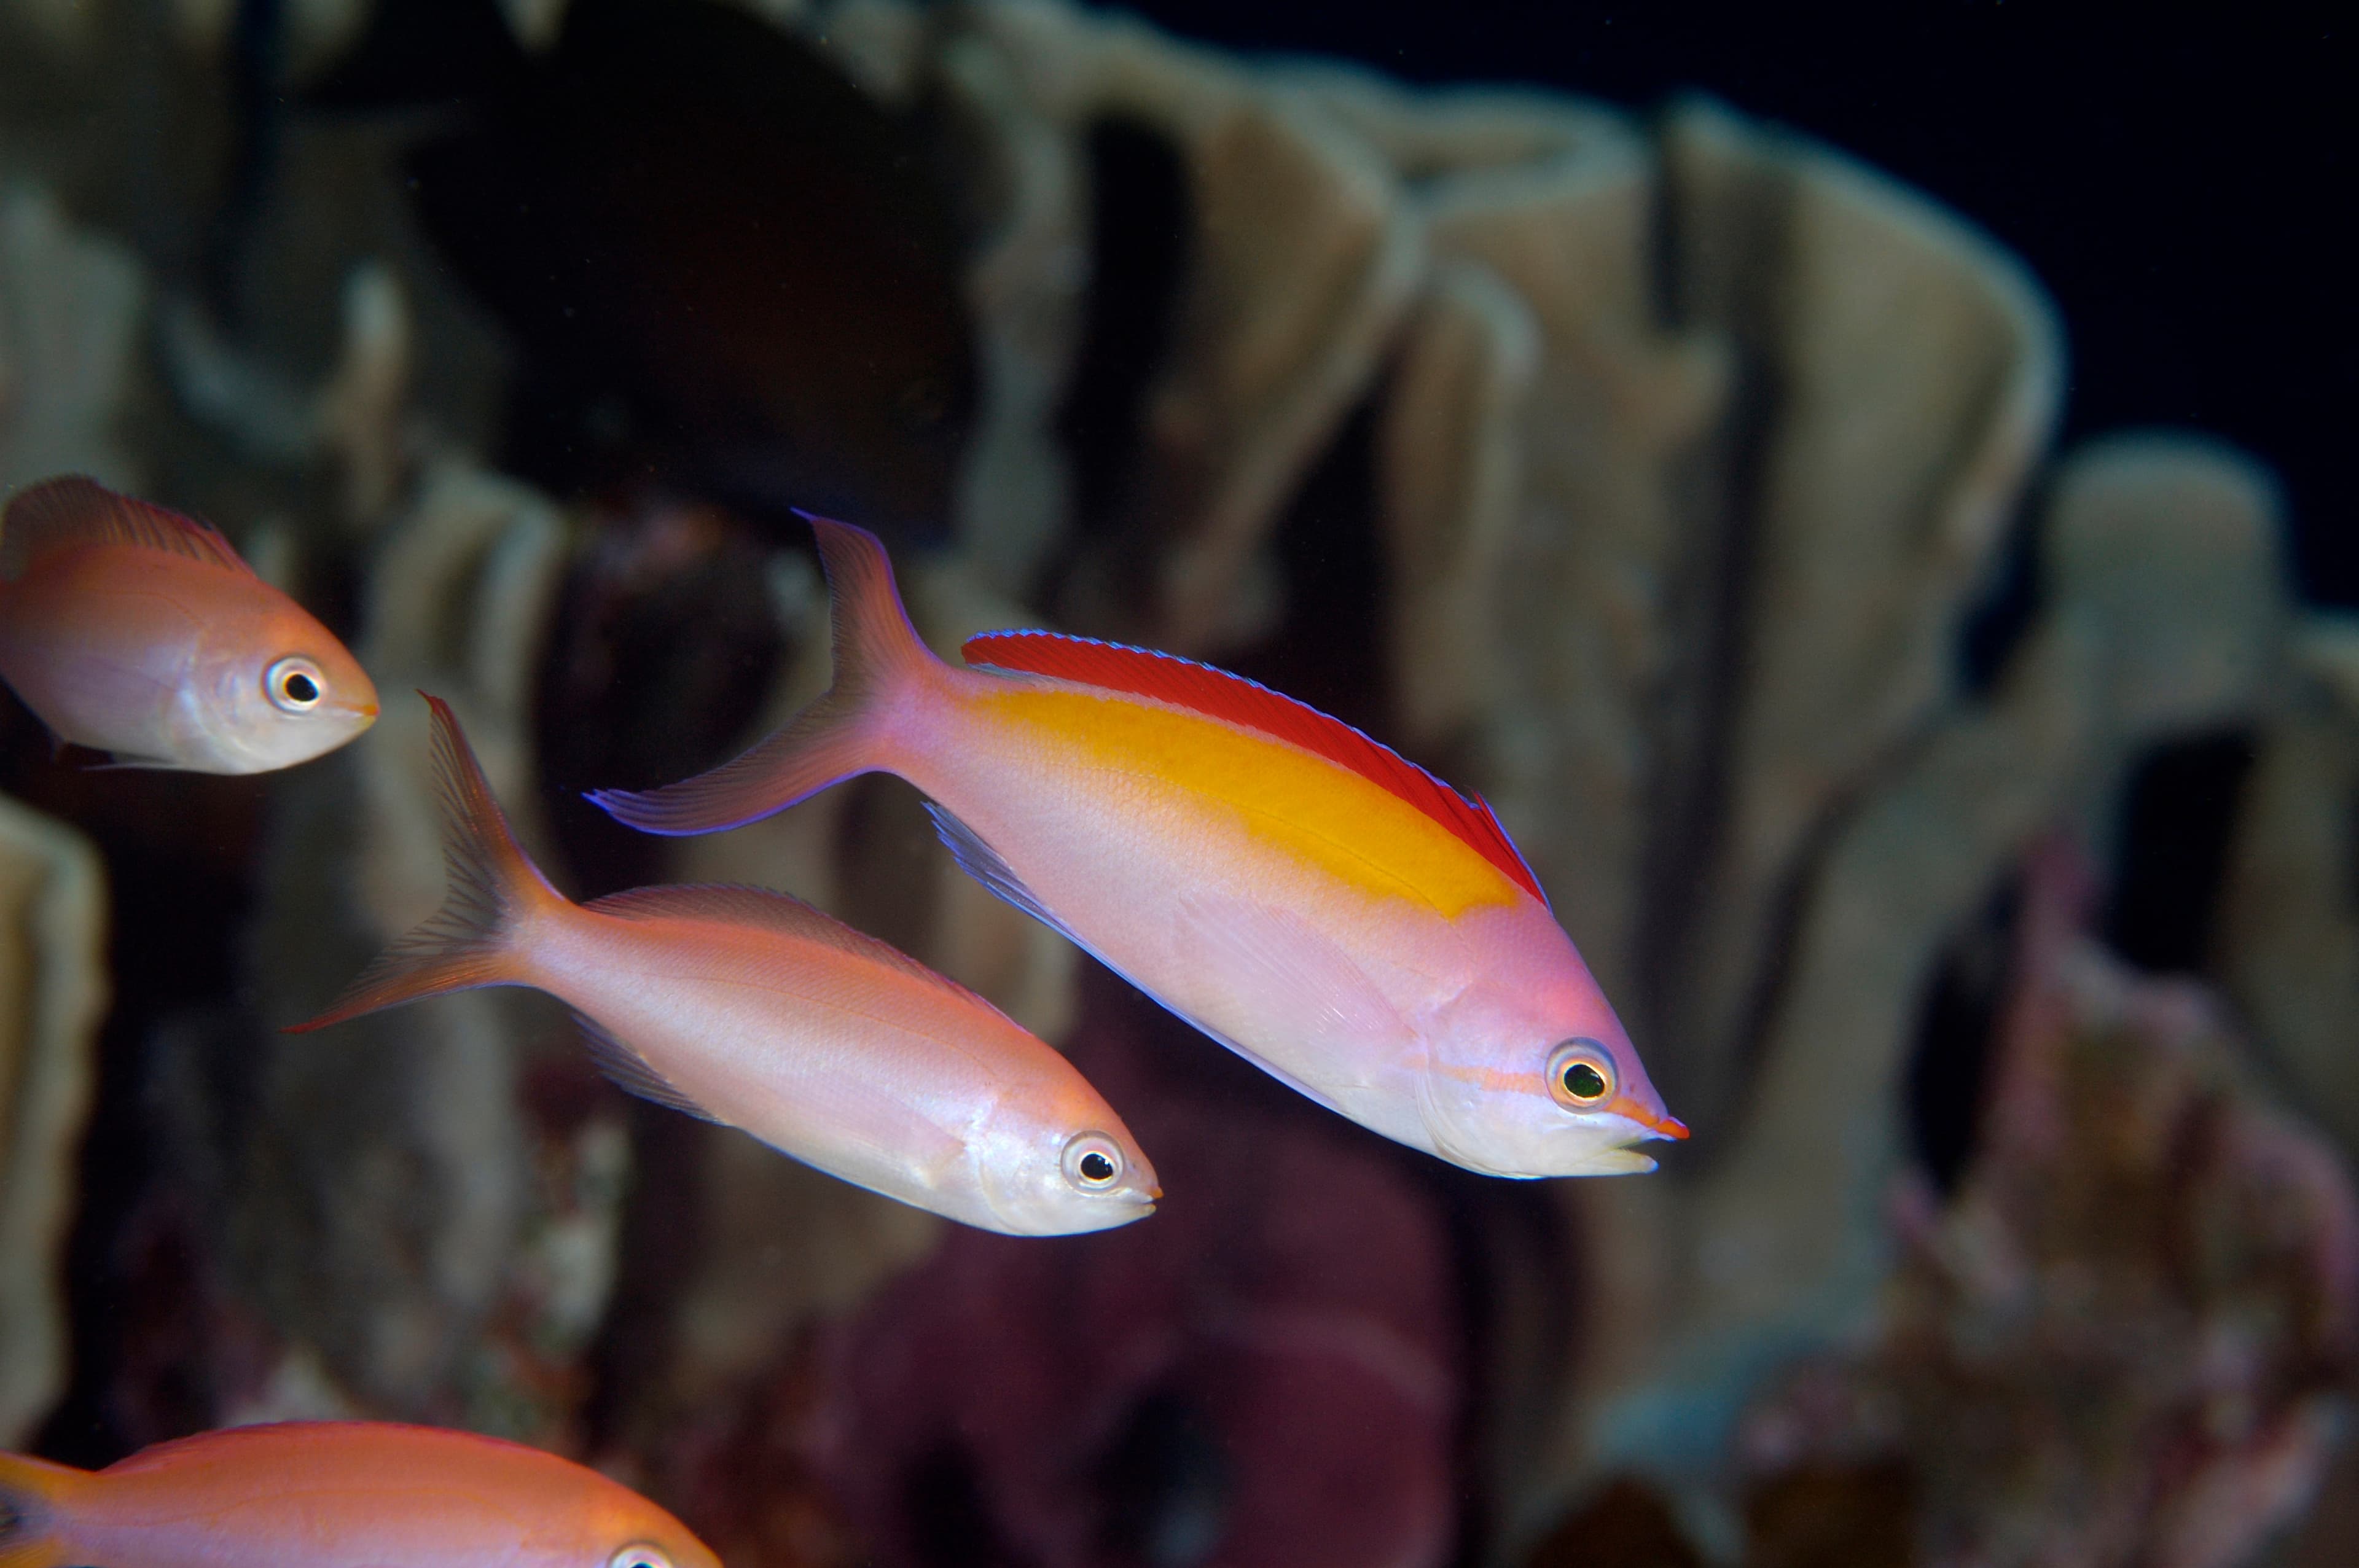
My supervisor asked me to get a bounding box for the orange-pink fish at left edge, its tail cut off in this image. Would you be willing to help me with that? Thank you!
[0,476,377,773]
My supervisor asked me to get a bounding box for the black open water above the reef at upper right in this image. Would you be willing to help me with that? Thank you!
[1094,0,2359,606]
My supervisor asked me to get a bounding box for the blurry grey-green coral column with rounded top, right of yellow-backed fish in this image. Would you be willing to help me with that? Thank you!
[1573,436,2291,1537]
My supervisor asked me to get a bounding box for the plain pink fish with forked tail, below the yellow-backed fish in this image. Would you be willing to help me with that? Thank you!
[295,698,1160,1236]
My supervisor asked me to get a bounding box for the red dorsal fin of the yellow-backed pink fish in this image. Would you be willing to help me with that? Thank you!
[960,632,1547,908]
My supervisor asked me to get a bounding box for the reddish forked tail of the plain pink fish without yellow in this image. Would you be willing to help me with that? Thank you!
[288,691,566,1035]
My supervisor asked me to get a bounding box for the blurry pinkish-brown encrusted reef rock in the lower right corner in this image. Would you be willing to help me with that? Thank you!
[1741,854,2359,1568]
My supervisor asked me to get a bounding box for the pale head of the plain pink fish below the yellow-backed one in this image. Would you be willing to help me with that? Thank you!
[974,1073,1163,1236]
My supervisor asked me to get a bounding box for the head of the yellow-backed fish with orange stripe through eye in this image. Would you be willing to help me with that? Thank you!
[1420,919,1687,1177]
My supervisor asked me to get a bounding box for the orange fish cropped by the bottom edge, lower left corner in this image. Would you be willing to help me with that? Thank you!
[0,1422,719,1568]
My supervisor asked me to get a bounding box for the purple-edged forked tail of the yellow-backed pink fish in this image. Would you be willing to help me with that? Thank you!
[590,512,939,835]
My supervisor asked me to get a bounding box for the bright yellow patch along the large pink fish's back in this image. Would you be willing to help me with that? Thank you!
[979,679,1522,919]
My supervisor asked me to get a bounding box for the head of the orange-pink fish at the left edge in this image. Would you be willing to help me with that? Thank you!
[191,590,377,773]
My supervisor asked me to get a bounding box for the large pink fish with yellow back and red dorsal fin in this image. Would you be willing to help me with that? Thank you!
[590,519,1687,1177]
